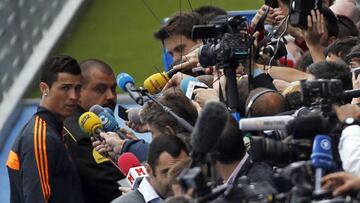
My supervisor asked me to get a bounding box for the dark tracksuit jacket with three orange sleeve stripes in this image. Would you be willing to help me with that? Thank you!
[6,107,83,203]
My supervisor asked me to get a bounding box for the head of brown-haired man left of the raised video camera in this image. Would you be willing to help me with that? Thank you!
[154,12,203,62]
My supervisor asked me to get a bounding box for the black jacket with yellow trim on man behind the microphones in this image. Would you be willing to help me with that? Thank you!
[64,106,124,203]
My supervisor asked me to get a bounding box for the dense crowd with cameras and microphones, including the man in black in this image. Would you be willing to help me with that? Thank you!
[8,0,360,203]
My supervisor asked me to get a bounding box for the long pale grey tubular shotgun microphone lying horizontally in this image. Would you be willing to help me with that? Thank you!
[239,115,295,131]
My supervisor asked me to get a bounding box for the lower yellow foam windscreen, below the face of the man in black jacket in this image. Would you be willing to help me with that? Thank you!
[79,112,102,134]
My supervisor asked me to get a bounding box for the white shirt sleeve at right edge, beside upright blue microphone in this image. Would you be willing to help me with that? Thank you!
[338,125,360,175]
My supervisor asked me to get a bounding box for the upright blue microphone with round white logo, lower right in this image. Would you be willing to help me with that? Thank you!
[311,135,333,194]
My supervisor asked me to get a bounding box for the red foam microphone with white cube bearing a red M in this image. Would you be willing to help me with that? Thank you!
[118,152,149,189]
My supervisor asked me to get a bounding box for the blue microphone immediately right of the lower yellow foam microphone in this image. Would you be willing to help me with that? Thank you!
[89,104,126,139]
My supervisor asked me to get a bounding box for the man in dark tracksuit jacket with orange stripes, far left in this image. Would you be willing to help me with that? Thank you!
[6,55,83,202]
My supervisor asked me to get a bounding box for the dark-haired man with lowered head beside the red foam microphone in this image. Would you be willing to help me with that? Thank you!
[113,135,189,203]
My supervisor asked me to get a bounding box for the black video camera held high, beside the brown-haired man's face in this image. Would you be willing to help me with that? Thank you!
[192,15,251,69]
